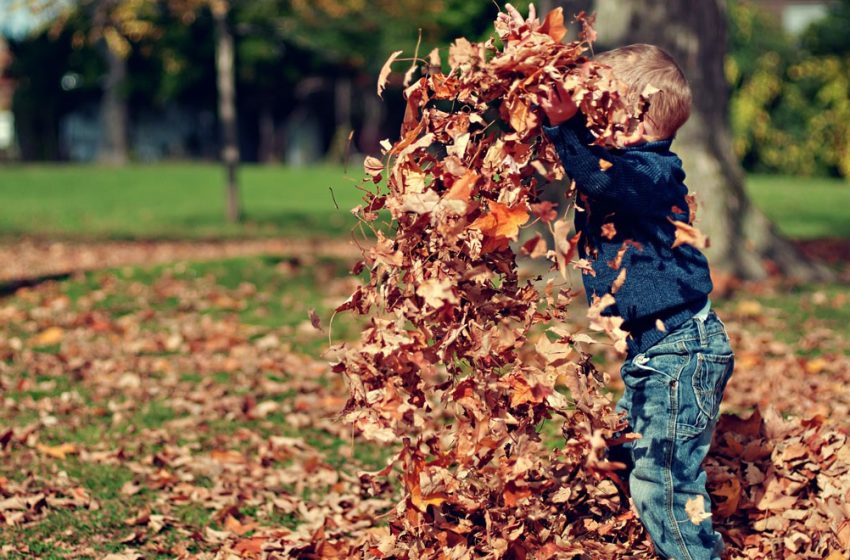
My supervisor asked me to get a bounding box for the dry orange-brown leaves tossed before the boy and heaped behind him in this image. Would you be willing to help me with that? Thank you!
[334,5,848,559]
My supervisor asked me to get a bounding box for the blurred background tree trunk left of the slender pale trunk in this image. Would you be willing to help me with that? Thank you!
[98,41,128,165]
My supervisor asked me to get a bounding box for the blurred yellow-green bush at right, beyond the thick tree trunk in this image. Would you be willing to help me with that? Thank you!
[726,0,850,177]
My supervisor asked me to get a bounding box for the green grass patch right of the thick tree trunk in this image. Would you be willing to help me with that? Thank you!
[747,175,850,239]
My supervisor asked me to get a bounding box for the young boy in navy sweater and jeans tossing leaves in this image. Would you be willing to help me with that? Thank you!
[544,44,733,560]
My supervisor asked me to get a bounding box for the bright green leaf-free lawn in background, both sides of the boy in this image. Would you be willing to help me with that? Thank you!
[0,164,850,239]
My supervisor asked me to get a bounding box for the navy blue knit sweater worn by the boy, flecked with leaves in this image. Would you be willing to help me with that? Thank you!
[544,113,712,356]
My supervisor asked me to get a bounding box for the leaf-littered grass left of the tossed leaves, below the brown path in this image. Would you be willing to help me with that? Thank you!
[0,257,388,559]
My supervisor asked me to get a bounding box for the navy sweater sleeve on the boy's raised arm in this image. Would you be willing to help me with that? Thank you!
[543,113,676,213]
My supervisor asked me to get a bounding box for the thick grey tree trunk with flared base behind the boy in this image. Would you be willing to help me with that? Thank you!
[596,0,829,280]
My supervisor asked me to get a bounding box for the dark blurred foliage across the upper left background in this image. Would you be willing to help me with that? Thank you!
[6,0,528,159]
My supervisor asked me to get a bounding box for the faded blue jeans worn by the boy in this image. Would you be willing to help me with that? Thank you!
[612,311,734,560]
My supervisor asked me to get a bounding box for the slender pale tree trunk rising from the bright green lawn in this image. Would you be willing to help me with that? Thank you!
[211,0,242,222]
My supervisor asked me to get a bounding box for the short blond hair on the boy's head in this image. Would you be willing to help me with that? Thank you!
[594,43,692,138]
